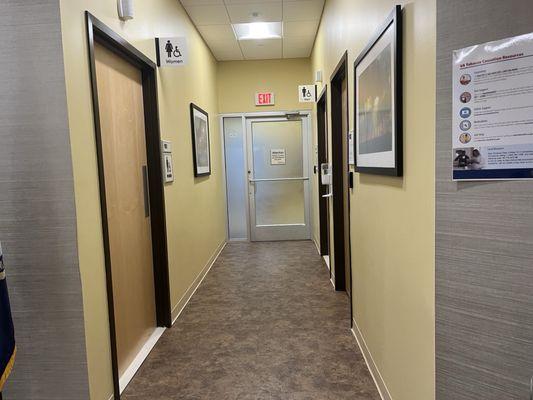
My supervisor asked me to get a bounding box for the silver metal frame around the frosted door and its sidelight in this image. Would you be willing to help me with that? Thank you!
[219,110,313,241]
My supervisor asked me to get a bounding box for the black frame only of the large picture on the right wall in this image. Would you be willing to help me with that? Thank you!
[353,5,403,177]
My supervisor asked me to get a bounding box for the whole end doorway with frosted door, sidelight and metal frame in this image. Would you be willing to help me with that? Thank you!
[221,112,311,241]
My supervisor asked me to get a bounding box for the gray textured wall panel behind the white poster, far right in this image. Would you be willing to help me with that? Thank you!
[436,0,533,400]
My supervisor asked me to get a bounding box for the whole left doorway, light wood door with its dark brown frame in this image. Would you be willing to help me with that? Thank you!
[86,13,171,399]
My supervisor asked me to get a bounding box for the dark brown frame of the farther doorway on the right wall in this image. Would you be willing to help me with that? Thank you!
[316,85,331,262]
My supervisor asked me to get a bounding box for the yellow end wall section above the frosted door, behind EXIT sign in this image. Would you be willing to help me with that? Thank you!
[218,58,313,113]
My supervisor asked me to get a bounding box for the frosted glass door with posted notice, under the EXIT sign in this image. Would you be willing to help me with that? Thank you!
[247,117,310,241]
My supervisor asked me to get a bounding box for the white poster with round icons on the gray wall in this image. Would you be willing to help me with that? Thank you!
[451,33,533,180]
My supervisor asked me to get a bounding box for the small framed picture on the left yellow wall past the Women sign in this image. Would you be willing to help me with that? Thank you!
[191,103,211,176]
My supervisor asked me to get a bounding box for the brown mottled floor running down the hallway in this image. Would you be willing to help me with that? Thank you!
[122,241,379,400]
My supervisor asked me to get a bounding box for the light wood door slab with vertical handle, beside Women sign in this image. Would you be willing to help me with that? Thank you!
[94,44,157,376]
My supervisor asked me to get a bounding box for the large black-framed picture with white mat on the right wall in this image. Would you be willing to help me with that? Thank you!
[354,6,403,176]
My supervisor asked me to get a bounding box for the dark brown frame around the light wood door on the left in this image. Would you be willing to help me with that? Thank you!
[85,11,172,400]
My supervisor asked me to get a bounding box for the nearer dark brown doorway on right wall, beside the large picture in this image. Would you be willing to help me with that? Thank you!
[331,52,351,297]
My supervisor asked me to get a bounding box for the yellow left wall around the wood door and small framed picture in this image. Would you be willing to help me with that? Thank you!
[61,0,226,400]
